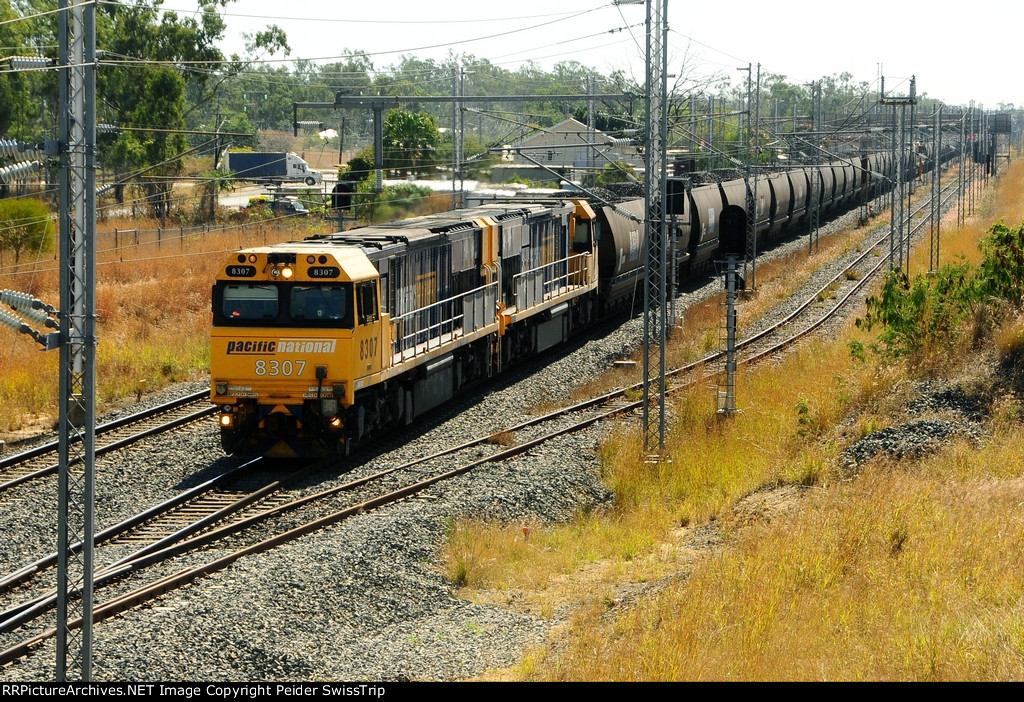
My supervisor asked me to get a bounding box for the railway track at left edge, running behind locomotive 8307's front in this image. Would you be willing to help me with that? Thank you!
[0,391,216,498]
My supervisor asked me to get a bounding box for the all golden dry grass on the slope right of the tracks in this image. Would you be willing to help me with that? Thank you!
[447,164,1024,681]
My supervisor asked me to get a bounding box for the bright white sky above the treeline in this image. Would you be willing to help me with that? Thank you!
[176,0,1024,108]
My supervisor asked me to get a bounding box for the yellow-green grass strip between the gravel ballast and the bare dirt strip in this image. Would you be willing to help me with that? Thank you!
[446,319,881,589]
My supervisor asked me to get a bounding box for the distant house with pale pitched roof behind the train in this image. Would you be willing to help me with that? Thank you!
[496,118,643,180]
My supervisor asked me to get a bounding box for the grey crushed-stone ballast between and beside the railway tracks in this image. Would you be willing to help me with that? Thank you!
[0,199,962,681]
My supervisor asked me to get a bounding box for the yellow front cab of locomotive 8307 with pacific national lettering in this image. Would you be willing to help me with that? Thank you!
[210,245,389,456]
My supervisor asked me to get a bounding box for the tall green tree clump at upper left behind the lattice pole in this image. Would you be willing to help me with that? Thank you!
[0,0,287,217]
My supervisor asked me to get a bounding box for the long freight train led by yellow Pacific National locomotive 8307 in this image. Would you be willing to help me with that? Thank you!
[210,149,950,456]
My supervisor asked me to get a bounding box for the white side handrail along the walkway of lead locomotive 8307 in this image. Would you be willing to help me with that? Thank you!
[391,281,498,360]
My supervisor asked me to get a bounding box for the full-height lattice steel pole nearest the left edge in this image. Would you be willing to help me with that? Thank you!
[56,0,96,682]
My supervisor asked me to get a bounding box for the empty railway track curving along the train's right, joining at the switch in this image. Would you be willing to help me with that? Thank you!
[0,177,966,664]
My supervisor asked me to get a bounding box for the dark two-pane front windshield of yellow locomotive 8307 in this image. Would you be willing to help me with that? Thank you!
[213,282,355,328]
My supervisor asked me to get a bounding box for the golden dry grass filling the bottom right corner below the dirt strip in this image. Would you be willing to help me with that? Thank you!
[540,458,1024,681]
